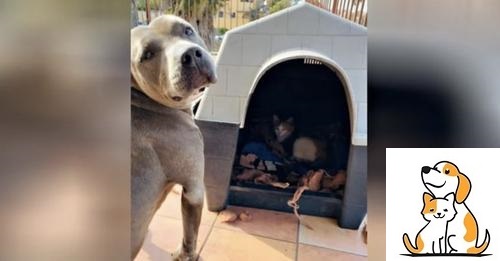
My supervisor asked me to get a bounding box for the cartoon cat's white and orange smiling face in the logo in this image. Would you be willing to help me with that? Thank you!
[422,192,457,221]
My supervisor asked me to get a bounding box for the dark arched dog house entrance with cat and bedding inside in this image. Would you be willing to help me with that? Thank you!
[229,58,351,217]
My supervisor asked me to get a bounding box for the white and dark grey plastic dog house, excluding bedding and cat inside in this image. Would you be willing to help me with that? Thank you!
[196,3,367,228]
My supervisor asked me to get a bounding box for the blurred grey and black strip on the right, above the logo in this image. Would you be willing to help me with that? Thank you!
[368,0,500,260]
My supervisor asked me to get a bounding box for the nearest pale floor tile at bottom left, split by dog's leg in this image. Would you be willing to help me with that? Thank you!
[135,215,210,261]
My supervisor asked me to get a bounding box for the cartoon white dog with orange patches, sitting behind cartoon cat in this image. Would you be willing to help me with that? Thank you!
[421,161,490,254]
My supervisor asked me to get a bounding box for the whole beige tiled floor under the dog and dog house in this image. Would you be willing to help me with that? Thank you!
[136,184,367,261]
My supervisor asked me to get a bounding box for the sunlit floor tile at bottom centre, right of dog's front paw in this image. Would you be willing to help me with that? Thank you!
[199,228,296,261]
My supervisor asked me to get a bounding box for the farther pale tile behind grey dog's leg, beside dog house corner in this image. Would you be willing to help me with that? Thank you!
[156,185,217,225]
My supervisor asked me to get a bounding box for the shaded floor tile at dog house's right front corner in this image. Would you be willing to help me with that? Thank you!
[299,215,368,256]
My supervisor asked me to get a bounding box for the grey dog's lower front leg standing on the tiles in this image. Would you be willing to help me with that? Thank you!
[174,185,205,260]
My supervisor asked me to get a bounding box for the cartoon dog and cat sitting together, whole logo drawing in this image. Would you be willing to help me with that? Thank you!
[402,161,490,256]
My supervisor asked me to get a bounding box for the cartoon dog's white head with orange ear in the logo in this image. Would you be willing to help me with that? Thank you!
[422,161,471,203]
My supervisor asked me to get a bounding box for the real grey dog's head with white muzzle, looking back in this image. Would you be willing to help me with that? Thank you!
[130,15,217,109]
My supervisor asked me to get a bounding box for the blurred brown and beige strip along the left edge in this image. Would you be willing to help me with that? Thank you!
[0,0,130,260]
